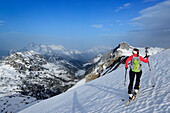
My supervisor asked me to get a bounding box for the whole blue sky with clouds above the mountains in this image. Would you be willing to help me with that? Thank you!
[0,0,170,51]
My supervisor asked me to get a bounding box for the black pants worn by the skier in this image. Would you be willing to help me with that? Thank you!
[128,70,142,94]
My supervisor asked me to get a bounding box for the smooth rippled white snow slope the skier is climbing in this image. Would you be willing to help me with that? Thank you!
[20,49,170,113]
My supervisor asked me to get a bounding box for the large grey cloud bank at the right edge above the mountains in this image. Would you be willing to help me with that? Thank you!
[128,0,170,47]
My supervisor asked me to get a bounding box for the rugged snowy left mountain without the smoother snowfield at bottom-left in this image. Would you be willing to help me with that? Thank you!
[0,51,77,99]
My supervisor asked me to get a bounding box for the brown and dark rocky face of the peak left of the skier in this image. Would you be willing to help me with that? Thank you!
[86,42,132,82]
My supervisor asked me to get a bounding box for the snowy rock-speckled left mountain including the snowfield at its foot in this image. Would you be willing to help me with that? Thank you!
[0,51,81,113]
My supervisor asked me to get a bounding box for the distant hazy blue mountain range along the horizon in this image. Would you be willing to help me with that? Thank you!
[21,43,111,62]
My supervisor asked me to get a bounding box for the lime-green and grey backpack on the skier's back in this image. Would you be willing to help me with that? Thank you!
[130,56,142,72]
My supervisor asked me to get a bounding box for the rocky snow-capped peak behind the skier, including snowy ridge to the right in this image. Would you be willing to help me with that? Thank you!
[86,42,164,82]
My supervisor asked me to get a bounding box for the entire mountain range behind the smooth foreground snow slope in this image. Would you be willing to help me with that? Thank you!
[0,42,163,112]
